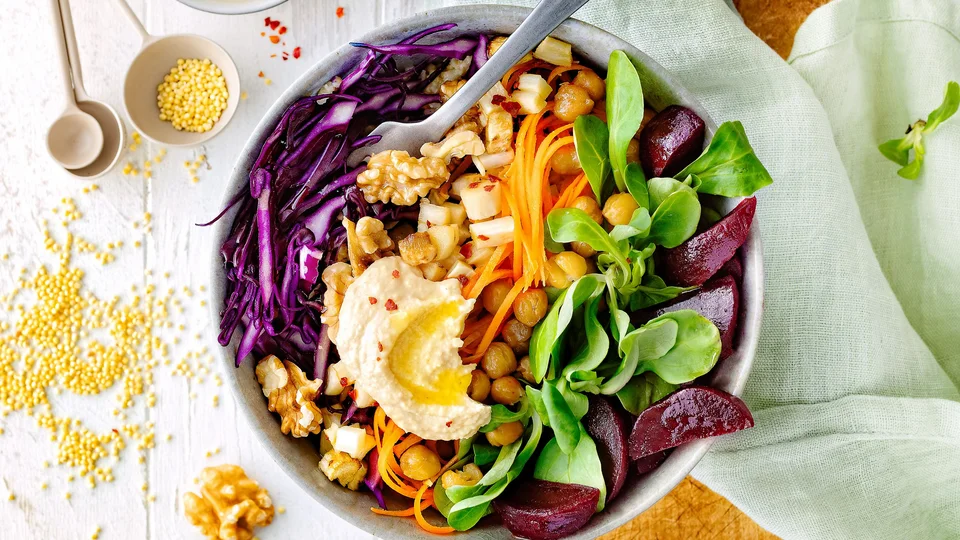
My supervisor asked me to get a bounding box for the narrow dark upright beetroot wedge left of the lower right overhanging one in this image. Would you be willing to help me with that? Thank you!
[583,395,630,502]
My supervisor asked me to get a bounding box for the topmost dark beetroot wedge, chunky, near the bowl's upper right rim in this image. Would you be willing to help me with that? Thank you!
[640,105,705,180]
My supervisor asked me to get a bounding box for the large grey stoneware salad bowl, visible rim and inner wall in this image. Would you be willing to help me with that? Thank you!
[209,5,763,540]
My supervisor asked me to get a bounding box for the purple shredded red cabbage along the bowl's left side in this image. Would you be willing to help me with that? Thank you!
[212,24,489,374]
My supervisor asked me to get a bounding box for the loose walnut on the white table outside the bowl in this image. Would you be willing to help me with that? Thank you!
[183,465,274,540]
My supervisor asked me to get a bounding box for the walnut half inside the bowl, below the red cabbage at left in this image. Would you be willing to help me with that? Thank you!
[256,355,323,437]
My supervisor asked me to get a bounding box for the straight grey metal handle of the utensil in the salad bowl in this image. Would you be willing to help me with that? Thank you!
[429,0,589,131]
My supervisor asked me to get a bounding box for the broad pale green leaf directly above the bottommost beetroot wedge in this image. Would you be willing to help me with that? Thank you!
[533,424,607,512]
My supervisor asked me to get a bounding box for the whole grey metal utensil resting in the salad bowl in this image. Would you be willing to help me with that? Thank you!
[347,0,589,167]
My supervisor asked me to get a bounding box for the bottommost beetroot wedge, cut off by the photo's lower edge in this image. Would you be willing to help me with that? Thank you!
[493,479,600,540]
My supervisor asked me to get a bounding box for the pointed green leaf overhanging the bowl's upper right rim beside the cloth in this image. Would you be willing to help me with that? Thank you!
[676,121,773,197]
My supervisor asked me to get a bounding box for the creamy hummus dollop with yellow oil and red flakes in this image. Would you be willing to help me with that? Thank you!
[337,257,490,440]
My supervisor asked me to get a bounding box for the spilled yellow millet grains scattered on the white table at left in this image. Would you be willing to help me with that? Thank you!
[0,199,213,497]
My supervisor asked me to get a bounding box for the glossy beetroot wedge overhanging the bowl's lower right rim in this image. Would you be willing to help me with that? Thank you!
[630,386,753,460]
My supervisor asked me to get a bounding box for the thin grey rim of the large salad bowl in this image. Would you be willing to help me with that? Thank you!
[208,4,764,539]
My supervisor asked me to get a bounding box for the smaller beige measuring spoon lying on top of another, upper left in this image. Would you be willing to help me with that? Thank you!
[47,0,103,170]
